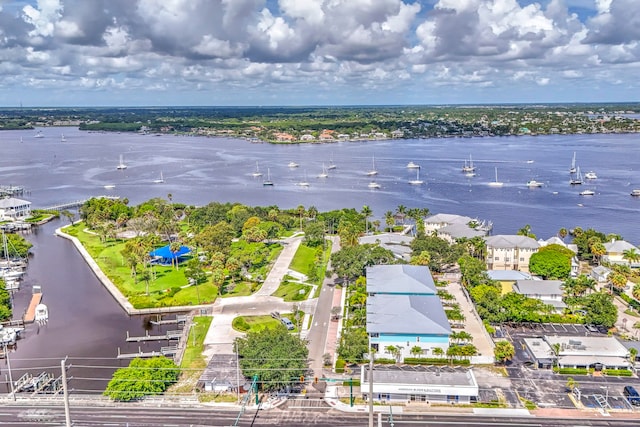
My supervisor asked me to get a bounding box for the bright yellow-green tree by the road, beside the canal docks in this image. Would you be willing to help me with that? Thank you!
[104,356,180,402]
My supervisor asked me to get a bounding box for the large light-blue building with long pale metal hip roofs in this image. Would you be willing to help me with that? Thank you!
[366,265,451,361]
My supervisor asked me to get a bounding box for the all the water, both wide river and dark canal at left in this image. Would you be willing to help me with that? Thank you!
[0,128,640,390]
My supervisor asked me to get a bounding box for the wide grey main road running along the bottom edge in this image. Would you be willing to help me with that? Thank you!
[0,404,638,427]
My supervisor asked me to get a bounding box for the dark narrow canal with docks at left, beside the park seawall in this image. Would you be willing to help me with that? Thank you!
[5,219,176,392]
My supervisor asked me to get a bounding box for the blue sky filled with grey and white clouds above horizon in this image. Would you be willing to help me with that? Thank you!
[0,0,640,107]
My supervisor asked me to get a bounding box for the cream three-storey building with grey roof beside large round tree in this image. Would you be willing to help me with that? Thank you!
[485,234,540,273]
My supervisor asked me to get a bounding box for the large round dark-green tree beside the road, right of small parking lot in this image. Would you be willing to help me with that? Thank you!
[236,325,309,392]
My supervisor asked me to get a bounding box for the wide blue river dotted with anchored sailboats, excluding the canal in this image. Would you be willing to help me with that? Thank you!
[0,128,640,244]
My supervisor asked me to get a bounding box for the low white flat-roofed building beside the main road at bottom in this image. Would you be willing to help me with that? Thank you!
[360,365,478,403]
